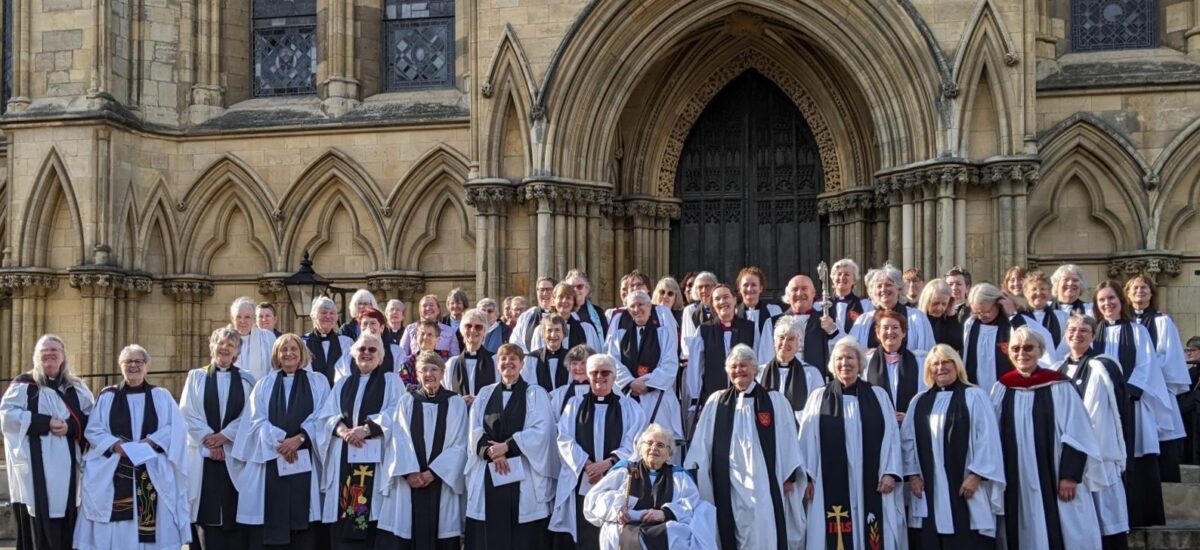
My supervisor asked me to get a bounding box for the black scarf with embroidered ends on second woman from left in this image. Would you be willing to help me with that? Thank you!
[103,381,158,543]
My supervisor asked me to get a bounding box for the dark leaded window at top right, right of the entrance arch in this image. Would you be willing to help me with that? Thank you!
[1070,0,1158,52]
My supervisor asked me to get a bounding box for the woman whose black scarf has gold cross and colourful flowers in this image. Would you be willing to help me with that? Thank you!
[317,329,403,550]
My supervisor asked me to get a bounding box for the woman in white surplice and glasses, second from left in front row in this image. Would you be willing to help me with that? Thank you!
[74,345,192,550]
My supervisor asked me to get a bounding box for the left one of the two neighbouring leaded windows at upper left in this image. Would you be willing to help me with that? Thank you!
[253,0,317,97]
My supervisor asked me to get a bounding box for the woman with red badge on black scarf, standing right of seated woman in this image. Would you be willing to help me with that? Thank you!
[684,343,806,550]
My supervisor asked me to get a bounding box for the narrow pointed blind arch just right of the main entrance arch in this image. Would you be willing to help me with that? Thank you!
[954,0,1020,157]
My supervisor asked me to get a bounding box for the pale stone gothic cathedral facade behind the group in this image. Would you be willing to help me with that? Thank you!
[0,0,1200,386]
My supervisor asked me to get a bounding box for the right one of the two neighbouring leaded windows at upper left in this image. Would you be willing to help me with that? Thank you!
[384,0,454,91]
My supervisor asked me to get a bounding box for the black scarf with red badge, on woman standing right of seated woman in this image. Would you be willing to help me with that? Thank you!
[709,381,787,550]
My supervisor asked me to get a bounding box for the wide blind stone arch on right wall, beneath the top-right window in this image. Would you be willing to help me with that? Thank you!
[1028,116,1148,253]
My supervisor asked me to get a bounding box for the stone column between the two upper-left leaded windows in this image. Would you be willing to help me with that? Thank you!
[317,0,361,116]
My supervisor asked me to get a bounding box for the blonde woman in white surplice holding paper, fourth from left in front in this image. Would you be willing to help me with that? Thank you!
[233,334,330,550]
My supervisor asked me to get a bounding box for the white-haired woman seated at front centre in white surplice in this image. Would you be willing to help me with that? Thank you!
[583,424,716,550]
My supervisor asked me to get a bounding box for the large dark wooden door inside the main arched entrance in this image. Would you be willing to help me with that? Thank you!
[671,70,829,299]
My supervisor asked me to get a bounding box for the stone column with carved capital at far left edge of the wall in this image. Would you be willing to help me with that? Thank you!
[0,269,59,373]
